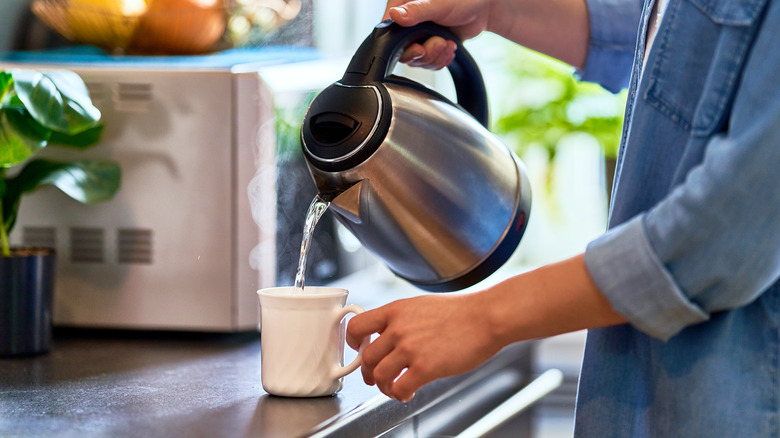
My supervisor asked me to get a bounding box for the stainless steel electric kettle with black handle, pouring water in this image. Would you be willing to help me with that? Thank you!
[301,20,531,292]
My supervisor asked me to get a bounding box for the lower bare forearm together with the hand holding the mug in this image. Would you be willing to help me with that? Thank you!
[347,252,624,401]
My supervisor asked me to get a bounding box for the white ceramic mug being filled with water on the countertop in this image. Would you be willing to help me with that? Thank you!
[257,286,368,397]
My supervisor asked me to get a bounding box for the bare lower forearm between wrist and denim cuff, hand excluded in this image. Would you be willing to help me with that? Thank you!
[475,255,626,345]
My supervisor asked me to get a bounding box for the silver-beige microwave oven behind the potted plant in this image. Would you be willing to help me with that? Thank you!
[0,48,354,332]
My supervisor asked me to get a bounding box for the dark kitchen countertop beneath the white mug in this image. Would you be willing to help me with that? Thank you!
[0,268,548,437]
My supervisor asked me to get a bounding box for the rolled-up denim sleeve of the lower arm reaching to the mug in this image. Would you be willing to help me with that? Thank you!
[585,8,780,339]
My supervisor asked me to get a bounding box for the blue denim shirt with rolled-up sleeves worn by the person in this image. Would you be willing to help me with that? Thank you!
[575,0,780,438]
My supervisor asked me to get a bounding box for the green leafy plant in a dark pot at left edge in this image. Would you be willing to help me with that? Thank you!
[0,69,120,356]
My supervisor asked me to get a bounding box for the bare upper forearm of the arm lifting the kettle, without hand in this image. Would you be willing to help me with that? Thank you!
[488,0,590,68]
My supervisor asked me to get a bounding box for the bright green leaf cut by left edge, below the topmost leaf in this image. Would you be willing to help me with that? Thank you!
[0,108,51,167]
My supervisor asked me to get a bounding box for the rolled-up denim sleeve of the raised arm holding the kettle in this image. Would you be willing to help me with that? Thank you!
[577,0,642,93]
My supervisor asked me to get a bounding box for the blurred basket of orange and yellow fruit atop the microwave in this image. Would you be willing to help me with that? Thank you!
[31,0,300,55]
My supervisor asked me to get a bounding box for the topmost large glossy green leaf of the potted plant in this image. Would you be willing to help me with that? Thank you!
[11,69,100,135]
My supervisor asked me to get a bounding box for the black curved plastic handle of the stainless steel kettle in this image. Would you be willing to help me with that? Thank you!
[342,19,489,127]
